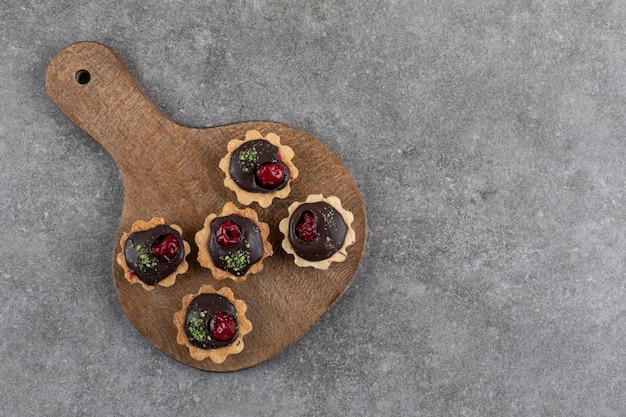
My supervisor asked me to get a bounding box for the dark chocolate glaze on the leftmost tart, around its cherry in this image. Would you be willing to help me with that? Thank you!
[124,224,185,285]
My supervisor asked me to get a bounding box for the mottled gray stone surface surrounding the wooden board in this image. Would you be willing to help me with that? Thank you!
[0,0,626,417]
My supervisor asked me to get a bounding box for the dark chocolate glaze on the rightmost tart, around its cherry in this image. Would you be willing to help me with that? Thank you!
[289,201,348,262]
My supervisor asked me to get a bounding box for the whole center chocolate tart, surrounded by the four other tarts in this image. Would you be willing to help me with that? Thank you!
[195,202,273,282]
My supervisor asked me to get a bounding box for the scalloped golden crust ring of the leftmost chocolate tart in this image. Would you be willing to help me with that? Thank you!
[115,217,191,291]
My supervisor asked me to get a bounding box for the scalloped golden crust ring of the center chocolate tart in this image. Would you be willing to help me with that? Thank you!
[195,201,274,282]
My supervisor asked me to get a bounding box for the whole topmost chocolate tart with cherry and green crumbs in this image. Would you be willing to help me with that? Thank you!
[219,130,298,207]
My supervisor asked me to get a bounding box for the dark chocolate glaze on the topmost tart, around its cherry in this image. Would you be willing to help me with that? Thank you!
[230,139,290,193]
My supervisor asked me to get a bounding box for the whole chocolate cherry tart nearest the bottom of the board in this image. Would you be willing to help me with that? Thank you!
[174,285,252,364]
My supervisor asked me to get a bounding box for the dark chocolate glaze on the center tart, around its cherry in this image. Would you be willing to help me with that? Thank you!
[209,214,263,276]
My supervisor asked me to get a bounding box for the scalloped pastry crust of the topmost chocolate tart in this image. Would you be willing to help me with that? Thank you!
[219,130,298,208]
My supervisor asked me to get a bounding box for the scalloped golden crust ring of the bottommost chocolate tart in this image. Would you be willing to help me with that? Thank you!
[173,285,252,364]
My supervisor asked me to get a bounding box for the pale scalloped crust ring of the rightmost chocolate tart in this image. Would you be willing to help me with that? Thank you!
[278,194,356,270]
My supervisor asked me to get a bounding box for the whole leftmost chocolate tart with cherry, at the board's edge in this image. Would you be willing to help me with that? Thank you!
[116,217,191,291]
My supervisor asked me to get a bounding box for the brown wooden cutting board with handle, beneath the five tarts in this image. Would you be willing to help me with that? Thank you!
[46,42,367,371]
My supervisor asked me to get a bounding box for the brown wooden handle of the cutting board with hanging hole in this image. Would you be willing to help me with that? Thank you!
[46,42,173,174]
